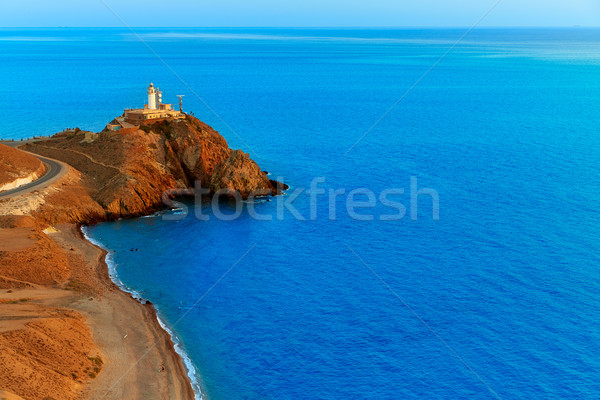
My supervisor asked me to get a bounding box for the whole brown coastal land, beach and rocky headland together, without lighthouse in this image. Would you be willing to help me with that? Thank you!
[0,116,285,400]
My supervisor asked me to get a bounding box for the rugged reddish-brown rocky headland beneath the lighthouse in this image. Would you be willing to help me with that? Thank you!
[24,116,278,222]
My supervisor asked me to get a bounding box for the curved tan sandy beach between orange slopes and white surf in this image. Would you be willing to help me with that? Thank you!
[55,225,194,399]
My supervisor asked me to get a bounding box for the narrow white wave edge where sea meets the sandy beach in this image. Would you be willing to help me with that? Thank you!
[82,225,207,400]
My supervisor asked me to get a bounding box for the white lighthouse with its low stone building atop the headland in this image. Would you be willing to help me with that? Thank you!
[106,83,185,130]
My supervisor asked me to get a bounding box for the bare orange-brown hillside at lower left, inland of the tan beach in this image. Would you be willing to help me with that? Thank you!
[0,216,103,399]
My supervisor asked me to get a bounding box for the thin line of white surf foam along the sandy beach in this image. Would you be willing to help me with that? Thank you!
[81,226,204,400]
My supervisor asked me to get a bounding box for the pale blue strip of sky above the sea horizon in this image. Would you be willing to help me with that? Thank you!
[0,0,600,27]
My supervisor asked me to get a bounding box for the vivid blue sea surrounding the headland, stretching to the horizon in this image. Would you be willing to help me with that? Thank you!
[0,28,600,400]
